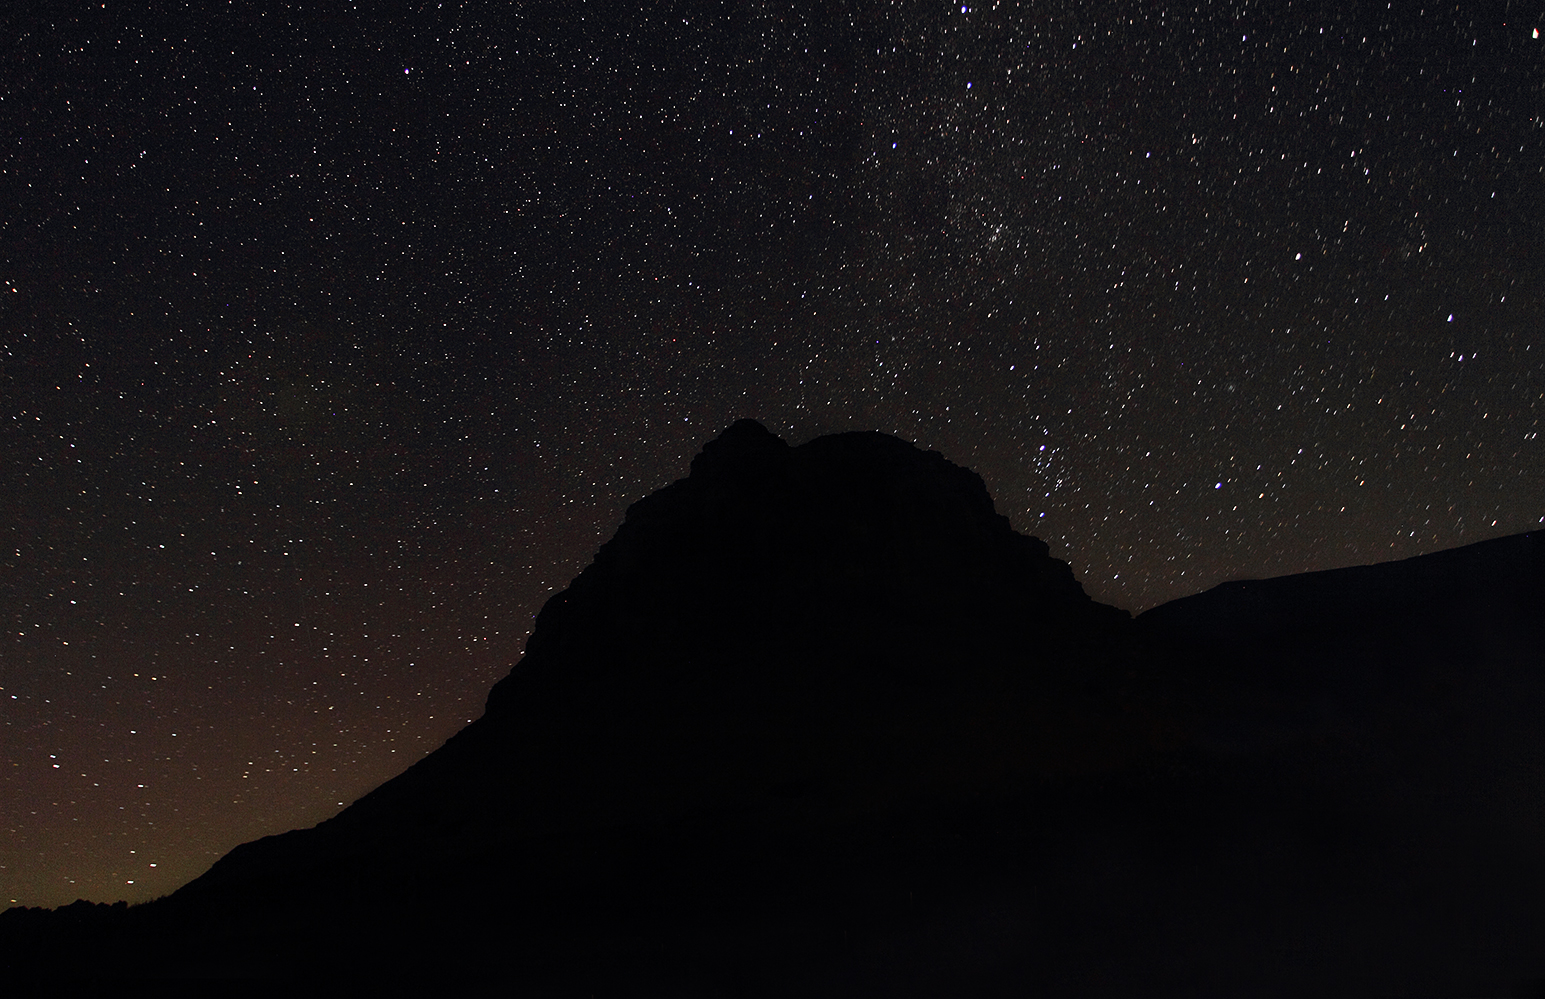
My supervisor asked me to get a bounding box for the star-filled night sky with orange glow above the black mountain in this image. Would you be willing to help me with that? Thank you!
[0,0,1545,905]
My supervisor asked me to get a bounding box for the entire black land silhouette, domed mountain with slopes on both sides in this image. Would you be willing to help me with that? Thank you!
[0,422,1545,996]
